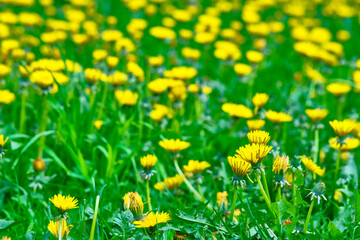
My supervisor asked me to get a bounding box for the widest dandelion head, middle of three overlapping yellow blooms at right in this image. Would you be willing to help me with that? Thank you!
[236,144,272,167]
